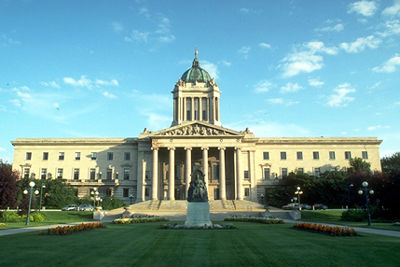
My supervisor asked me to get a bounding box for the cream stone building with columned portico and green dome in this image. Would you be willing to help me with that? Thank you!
[12,53,382,203]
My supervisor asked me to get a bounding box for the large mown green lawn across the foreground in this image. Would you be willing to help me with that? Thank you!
[0,223,400,267]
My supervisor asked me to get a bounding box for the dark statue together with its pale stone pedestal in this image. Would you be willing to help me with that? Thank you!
[185,170,212,227]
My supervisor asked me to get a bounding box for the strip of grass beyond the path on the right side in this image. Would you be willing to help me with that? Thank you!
[301,210,400,231]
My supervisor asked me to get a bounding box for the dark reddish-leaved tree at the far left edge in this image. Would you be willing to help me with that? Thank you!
[0,160,19,209]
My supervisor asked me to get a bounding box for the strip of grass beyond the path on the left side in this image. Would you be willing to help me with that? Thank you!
[0,211,93,231]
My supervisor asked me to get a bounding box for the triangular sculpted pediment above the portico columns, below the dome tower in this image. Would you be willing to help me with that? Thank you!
[149,121,244,137]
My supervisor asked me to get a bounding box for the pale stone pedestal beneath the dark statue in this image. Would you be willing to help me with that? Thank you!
[185,202,212,227]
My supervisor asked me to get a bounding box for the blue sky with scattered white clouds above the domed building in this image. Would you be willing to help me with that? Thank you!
[0,0,400,162]
